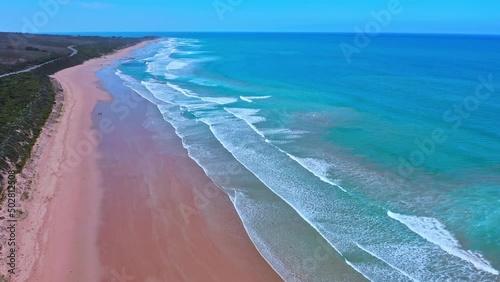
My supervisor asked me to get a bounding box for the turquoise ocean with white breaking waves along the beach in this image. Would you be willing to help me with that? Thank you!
[107,33,500,281]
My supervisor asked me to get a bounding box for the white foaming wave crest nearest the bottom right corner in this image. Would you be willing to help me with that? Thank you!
[387,211,499,275]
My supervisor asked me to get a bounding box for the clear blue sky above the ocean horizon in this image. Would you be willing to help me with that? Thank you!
[0,0,500,34]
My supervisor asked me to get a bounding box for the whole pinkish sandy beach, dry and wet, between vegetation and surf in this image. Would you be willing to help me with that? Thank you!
[9,40,280,282]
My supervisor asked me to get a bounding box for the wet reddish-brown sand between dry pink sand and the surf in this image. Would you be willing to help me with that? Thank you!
[94,43,282,282]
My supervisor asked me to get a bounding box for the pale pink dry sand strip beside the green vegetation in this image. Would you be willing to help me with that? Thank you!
[13,41,149,281]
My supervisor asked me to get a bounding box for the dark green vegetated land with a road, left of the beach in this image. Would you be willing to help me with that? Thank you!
[0,33,156,185]
